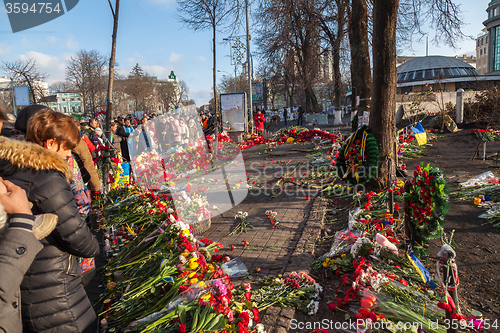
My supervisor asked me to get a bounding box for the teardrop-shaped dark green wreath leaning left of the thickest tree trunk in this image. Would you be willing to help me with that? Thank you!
[335,125,380,185]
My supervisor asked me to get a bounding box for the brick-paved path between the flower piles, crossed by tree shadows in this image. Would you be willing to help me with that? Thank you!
[202,144,325,333]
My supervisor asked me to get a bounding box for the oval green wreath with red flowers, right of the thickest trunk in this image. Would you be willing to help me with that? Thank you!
[405,164,449,252]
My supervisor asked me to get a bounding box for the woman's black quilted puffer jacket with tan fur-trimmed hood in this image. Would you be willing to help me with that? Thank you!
[0,137,99,333]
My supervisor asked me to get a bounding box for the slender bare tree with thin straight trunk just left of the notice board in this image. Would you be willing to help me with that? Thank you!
[177,0,241,126]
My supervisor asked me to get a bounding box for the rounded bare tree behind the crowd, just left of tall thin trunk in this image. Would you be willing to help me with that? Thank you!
[66,50,106,115]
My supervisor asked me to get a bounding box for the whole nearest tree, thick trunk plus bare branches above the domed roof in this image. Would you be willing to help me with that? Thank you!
[366,0,463,186]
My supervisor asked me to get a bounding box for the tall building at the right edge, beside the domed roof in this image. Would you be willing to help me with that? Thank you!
[483,0,500,73]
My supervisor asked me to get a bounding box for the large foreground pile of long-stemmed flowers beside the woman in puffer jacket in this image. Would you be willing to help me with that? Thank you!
[98,182,330,332]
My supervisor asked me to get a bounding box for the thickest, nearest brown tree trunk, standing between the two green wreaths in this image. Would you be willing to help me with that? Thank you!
[370,0,399,187]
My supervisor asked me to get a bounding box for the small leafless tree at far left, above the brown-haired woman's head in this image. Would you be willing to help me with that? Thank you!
[2,58,47,104]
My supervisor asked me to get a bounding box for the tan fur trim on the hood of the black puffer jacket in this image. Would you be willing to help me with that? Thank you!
[0,137,72,179]
